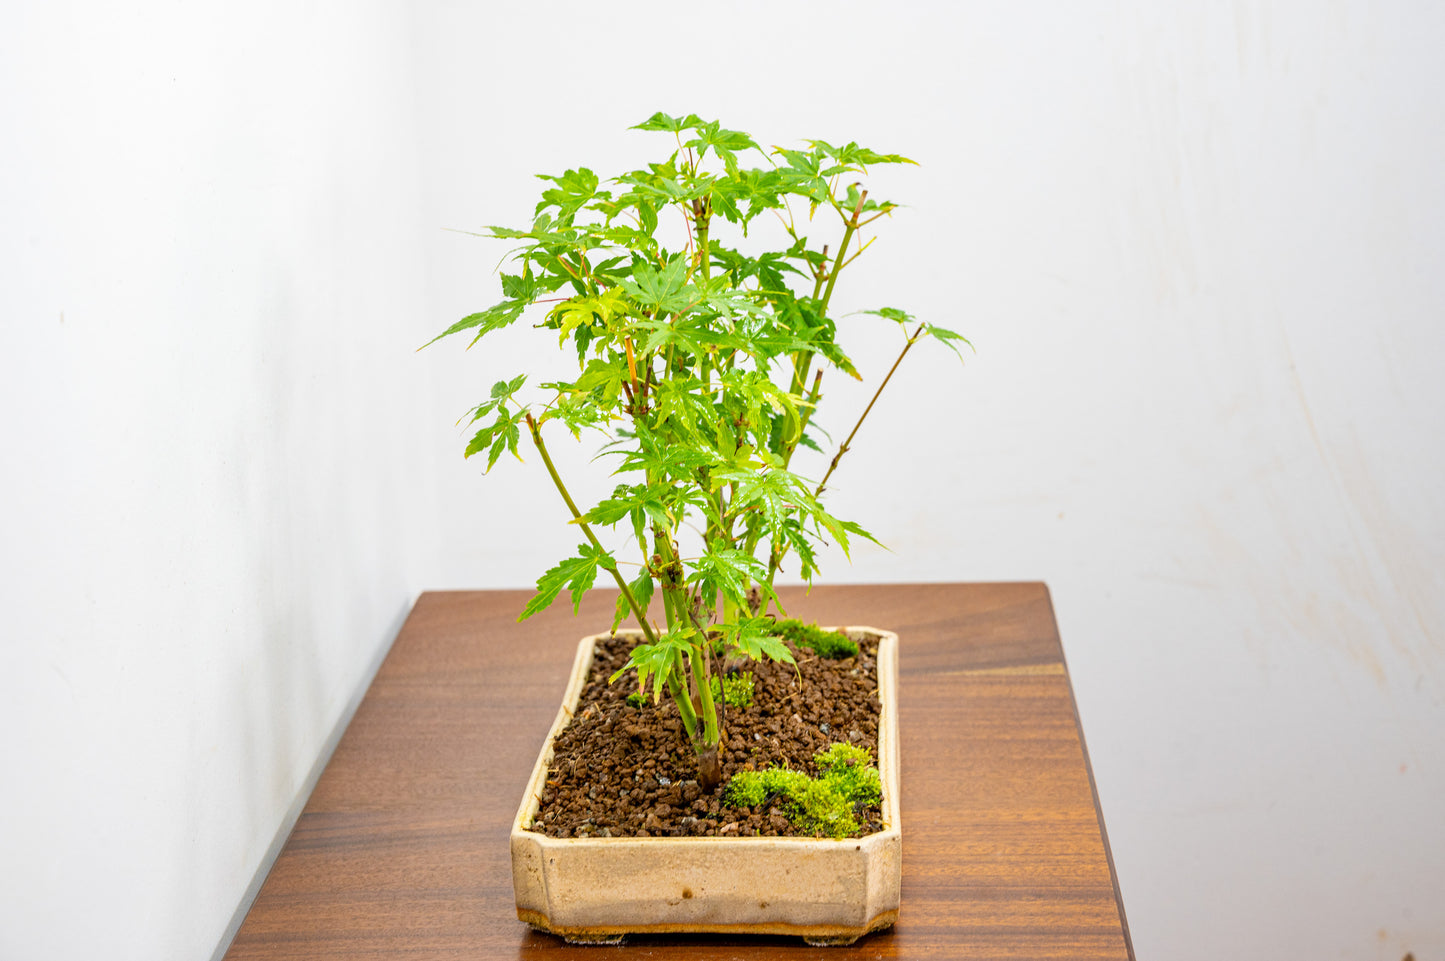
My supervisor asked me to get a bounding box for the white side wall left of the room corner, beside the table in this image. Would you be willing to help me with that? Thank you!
[0,0,434,961]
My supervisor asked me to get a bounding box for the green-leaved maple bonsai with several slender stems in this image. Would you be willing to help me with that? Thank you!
[421,113,967,792]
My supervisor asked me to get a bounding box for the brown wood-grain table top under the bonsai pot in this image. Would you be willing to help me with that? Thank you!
[225,584,1133,961]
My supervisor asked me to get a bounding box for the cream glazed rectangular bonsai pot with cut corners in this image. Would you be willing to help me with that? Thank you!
[512,627,903,945]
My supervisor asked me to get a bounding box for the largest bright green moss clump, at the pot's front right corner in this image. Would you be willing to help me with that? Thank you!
[723,743,883,838]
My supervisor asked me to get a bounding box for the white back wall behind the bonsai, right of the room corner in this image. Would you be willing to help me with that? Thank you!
[420,0,1445,960]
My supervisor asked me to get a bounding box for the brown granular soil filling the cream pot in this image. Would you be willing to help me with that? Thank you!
[532,636,883,838]
